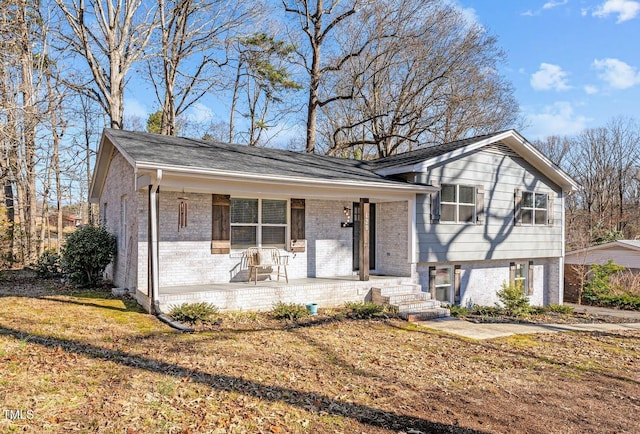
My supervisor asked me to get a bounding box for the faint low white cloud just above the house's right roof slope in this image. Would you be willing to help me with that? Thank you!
[525,101,592,139]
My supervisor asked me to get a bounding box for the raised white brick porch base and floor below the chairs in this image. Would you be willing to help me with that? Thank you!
[159,275,411,310]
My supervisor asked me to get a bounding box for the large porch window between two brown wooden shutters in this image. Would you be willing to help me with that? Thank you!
[231,198,287,249]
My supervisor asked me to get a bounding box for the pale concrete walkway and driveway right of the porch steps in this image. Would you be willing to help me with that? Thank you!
[417,305,640,340]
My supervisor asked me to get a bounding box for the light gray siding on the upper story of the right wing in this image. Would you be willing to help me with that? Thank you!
[417,149,563,262]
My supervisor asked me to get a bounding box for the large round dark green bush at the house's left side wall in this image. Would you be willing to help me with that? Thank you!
[62,226,116,286]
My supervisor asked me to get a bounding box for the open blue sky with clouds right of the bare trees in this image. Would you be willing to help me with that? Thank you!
[455,0,640,140]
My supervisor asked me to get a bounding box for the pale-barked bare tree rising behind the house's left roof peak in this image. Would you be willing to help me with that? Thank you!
[55,0,156,128]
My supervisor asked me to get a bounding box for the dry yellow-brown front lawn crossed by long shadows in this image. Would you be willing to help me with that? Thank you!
[0,274,640,433]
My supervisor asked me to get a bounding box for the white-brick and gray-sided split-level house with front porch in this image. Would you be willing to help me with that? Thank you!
[90,129,576,310]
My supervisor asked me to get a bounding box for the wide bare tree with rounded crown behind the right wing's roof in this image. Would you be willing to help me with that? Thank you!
[322,0,518,157]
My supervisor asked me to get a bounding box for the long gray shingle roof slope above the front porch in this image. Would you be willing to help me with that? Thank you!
[105,129,406,184]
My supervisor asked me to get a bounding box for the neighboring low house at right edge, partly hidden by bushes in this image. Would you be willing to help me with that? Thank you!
[564,240,640,302]
